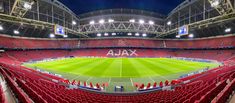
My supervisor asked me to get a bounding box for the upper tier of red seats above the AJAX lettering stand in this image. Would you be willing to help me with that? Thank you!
[0,35,235,49]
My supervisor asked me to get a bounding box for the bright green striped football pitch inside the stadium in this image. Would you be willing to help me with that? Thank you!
[24,58,219,91]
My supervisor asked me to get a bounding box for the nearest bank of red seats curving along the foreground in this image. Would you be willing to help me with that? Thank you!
[1,61,235,103]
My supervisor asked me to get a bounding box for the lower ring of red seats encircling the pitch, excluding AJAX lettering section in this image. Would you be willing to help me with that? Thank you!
[0,49,235,103]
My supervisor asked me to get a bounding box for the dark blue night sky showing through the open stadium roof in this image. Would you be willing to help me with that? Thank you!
[59,0,184,15]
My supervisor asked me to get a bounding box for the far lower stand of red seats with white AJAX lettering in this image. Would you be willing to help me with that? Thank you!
[0,49,235,64]
